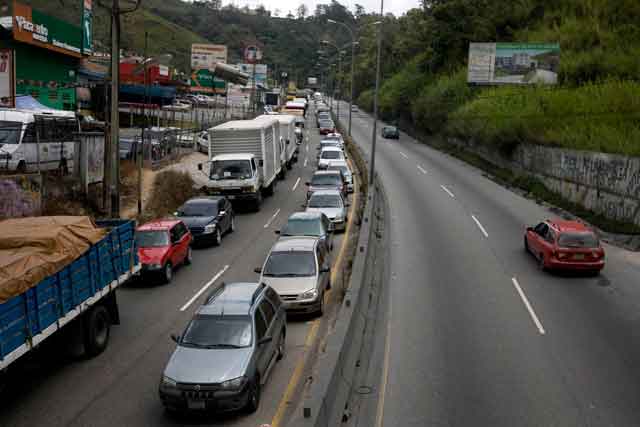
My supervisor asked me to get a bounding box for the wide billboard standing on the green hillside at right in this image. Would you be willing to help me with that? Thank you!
[467,43,560,85]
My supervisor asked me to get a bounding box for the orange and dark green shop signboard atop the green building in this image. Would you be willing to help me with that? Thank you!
[12,2,82,58]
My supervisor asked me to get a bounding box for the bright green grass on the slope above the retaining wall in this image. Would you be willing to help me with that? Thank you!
[447,80,640,155]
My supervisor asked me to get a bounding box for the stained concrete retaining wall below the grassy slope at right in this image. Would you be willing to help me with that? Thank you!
[448,138,640,225]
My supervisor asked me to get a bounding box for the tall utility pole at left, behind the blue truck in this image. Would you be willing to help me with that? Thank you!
[98,0,142,218]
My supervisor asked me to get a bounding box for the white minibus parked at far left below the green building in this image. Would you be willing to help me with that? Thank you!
[0,108,80,173]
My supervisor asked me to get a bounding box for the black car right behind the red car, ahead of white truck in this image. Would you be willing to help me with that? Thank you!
[175,196,235,246]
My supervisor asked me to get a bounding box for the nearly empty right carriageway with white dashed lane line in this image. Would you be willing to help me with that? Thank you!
[341,103,640,427]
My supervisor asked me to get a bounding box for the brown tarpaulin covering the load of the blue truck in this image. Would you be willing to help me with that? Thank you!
[0,216,107,304]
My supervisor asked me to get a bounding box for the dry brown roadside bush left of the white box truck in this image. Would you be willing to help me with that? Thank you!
[141,170,197,221]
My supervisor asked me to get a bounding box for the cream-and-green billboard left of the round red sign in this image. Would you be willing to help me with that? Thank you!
[191,44,227,94]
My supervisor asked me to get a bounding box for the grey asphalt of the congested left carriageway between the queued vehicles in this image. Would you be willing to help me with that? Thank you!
[0,112,342,427]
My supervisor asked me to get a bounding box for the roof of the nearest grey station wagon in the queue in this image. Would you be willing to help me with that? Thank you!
[198,283,264,316]
